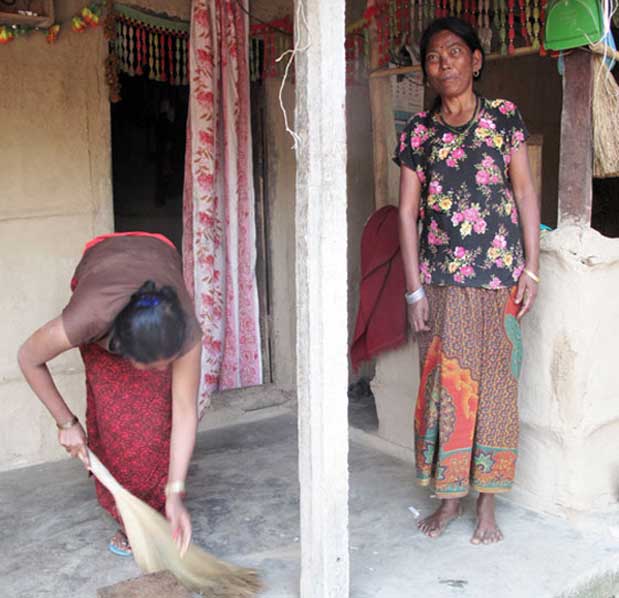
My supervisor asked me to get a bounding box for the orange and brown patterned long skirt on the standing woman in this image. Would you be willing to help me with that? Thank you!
[415,285,522,498]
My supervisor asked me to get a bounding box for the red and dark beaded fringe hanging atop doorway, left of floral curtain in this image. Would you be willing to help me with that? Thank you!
[113,4,189,85]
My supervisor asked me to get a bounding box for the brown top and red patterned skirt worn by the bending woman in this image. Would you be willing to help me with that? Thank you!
[62,233,200,520]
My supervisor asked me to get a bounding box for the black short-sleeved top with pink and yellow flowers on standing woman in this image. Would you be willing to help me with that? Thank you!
[394,98,528,289]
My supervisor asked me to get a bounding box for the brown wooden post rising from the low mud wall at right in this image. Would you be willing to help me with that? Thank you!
[559,50,593,226]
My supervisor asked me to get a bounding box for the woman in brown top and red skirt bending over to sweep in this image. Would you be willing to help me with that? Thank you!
[19,233,201,556]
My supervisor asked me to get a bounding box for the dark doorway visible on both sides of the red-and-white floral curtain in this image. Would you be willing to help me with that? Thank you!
[111,68,273,383]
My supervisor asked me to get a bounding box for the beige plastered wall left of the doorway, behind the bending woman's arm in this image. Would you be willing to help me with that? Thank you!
[0,19,113,470]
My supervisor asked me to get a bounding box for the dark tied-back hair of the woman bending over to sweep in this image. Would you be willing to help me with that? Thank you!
[109,280,185,363]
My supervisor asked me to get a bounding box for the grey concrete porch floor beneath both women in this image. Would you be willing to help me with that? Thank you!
[0,413,619,598]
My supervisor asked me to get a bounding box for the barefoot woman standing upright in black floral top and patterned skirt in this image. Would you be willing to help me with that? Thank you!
[396,17,539,544]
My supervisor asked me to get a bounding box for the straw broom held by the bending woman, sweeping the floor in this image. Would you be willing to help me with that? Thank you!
[89,451,261,598]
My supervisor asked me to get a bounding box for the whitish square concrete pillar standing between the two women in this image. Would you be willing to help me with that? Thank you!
[295,0,349,598]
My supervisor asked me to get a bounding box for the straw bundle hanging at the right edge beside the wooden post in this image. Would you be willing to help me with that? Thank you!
[592,49,619,178]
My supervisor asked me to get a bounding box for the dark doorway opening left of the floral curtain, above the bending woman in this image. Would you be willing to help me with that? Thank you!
[112,74,189,251]
